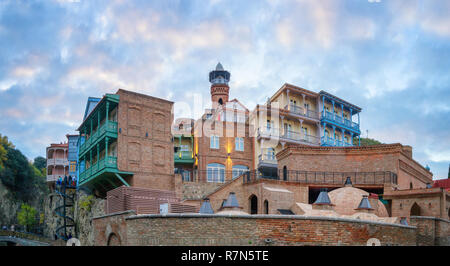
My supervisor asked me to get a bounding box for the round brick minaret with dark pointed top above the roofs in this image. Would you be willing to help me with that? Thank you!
[209,62,230,109]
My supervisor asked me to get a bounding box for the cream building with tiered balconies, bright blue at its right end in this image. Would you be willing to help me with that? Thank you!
[250,84,361,175]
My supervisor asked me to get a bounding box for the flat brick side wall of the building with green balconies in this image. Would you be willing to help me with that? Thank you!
[117,90,174,190]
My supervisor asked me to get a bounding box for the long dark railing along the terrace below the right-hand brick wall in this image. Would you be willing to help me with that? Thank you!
[244,170,397,185]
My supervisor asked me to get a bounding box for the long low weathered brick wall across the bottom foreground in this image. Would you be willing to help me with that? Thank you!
[93,214,416,246]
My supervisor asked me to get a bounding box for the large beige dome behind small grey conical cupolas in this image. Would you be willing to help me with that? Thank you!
[328,187,389,217]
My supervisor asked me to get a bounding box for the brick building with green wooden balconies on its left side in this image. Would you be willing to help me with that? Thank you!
[78,89,174,194]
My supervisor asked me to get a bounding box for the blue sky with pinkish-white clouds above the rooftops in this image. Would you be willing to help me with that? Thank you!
[0,0,450,179]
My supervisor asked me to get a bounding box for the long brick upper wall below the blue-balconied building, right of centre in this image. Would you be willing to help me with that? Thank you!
[277,144,433,189]
